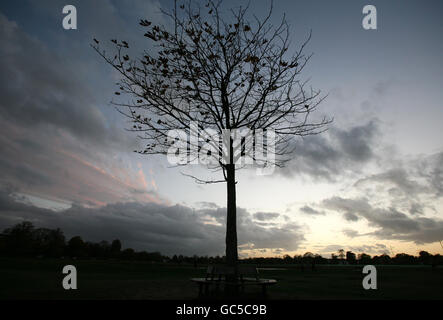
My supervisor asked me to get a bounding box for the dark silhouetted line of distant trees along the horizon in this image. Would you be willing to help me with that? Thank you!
[0,221,443,266]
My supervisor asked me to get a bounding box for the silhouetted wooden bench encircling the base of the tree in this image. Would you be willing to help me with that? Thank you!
[191,265,277,297]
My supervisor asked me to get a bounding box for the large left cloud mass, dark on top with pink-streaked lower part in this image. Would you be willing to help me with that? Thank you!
[0,13,166,205]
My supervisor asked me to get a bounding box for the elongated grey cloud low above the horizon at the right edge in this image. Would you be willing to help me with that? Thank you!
[323,197,443,244]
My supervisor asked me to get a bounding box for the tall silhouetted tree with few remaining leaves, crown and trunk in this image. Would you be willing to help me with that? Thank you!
[92,1,330,272]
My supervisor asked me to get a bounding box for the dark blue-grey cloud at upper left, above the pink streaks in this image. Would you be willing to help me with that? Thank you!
[0,13,128,146]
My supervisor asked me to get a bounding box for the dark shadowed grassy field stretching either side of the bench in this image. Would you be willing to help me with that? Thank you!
[0,258,443,300]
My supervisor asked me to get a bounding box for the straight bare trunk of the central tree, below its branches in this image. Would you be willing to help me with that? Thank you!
[226,162,238,269]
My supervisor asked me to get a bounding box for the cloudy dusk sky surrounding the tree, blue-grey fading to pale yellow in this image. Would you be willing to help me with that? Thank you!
[0,0,443,256]
